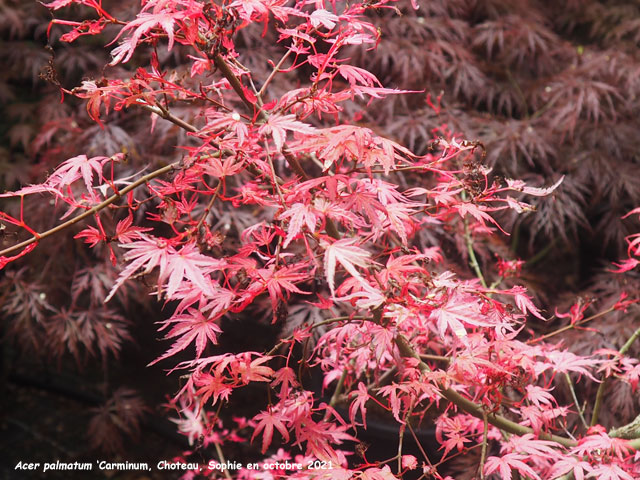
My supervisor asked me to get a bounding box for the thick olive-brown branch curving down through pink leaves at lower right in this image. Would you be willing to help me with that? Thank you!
[394,334,578,448]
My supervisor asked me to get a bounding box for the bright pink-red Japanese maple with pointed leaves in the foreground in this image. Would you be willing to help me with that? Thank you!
[0,0,640,479]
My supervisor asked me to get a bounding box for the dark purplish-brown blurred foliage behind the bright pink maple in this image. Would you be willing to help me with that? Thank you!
[0,0,640,472]
